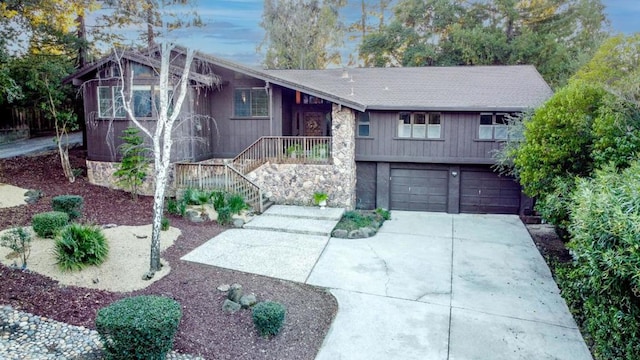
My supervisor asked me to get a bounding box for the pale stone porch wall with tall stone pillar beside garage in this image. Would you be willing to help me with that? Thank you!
[247,104,356,209]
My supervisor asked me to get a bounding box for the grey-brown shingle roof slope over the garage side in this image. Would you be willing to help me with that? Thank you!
[263,65,552,111]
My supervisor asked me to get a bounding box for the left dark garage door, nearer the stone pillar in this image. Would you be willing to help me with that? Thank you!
[390,169,448,211]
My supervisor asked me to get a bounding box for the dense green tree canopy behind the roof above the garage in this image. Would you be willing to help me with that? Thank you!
[360,0,606,86]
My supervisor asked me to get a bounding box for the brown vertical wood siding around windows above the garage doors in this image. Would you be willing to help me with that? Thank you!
[356,111,501,164]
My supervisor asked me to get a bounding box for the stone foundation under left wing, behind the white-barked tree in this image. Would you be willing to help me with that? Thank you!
[86,160,175,196]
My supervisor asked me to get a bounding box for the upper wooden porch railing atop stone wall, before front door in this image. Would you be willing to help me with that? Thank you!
[231,136,331,174]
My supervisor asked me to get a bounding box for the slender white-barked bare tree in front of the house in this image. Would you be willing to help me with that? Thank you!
[104,0,200,279]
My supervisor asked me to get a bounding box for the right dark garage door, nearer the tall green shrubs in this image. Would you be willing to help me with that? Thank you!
[460,170,520,214]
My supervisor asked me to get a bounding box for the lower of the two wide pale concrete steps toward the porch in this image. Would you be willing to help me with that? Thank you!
[243,214,338,236]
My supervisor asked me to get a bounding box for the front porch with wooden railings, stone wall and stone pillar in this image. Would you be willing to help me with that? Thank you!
[174,105,356,213]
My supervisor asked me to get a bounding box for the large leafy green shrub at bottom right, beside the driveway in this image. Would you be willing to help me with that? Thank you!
[557,162,640,359]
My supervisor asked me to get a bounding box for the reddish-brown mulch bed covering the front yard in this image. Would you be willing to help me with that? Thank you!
[0,149,337,359]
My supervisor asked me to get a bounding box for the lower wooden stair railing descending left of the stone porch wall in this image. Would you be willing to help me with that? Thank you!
[175,163,264,213]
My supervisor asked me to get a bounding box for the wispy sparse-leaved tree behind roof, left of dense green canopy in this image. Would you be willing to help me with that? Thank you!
[260,0,346,69]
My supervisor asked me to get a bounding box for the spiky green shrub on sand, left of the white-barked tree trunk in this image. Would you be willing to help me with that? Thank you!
[54,224,109,271]
